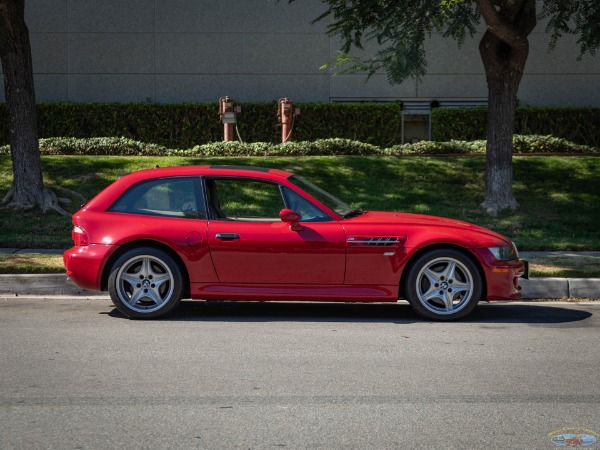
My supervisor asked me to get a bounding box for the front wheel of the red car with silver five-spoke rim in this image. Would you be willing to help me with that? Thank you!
[406,249,483,320]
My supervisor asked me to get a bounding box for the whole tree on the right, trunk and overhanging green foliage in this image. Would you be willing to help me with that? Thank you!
[316,0,600,215]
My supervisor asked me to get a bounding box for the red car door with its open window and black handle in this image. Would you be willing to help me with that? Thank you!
[205,178,346,285]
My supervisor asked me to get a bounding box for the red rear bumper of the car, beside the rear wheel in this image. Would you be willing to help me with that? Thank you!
[63,245,116,291]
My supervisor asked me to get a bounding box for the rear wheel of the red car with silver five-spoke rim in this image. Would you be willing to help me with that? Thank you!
[108,248,183,319]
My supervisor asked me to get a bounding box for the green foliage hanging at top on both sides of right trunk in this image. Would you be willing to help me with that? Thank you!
[314,0,600,84]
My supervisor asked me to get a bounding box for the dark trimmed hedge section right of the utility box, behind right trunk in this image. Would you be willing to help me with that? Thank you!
[432,106,600,147]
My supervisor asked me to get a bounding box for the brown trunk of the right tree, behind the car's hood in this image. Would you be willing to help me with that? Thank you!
[477,0,536,216]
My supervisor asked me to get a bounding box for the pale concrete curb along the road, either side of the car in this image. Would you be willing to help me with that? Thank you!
[0,274,600,299]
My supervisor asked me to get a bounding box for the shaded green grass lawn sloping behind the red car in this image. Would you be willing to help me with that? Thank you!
[0,156,600,250]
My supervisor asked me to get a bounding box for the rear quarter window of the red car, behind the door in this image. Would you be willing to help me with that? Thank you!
[109,177,206,219]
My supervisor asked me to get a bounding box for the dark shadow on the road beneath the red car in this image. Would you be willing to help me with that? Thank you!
[108,301,592,324]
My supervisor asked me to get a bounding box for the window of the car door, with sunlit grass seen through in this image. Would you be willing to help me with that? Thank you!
[206,178,285,222]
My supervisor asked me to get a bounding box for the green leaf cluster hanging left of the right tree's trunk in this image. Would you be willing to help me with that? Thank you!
[316,0,479,84]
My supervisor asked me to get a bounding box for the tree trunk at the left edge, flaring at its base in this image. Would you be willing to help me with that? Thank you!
[0,0,64,213]
